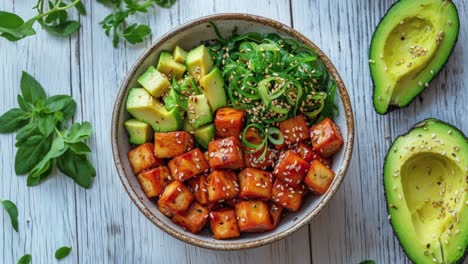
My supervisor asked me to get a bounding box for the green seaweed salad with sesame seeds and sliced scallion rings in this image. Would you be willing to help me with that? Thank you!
[207,23,338,151]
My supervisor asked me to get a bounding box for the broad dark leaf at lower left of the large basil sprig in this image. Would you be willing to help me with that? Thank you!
[15,135,52,175]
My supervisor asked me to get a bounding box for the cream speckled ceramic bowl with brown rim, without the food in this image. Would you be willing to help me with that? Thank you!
[111,13,354,250]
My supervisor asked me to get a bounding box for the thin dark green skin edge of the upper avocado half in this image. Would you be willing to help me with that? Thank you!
[368,0,460,116]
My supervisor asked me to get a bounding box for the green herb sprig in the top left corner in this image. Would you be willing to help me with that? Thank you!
[0,0,86,41]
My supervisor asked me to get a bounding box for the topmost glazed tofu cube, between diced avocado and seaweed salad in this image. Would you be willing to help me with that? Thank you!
[214,107,245,138]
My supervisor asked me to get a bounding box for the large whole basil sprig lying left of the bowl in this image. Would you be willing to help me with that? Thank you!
[0,72,96,188]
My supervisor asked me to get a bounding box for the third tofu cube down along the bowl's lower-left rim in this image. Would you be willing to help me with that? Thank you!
[158,181,195,217]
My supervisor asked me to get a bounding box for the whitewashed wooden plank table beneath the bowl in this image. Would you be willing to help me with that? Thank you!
[0,0,468,264]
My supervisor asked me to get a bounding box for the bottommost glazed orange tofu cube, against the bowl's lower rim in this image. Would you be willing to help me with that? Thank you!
[210,209,240,239]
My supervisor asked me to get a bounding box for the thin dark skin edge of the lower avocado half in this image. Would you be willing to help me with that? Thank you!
[382,117,468,264]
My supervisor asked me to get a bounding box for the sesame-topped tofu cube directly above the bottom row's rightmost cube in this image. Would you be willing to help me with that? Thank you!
[239,168,273,200]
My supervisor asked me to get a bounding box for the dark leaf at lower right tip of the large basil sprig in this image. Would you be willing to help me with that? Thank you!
[57,150,96,188]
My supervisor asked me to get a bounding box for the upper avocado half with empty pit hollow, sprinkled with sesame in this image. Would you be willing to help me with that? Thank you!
[369,0,460,114]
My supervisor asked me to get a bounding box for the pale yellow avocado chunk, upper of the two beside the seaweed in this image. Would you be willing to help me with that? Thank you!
[185,45,213,81]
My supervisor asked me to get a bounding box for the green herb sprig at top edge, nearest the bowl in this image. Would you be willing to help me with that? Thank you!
[98,0,176,47]
